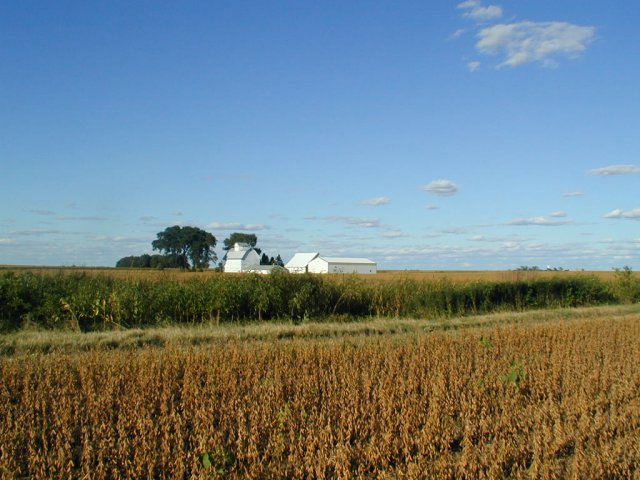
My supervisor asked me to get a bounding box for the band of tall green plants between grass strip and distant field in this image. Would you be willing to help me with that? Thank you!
[0,271,628,332]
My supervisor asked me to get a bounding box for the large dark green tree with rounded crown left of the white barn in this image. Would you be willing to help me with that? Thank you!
[151,225,218,269]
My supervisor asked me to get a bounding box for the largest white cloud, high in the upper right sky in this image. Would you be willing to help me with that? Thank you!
[476,21,595,67]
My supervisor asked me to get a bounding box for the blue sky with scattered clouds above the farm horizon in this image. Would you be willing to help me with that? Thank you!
[0,0,640,270]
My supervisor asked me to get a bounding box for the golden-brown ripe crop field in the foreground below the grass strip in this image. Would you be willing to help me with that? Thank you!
[0,309,640,479]
